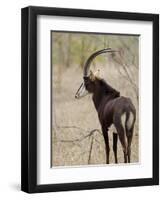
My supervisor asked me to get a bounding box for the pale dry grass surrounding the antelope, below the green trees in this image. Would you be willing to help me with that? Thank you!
[52,63,139,166]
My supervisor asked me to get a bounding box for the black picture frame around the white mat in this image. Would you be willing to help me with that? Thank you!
[21,6,159,193]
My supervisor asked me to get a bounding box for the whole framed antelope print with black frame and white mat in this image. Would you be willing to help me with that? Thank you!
[21,6,159,193]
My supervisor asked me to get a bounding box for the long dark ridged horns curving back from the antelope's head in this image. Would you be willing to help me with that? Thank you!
[83,48,117,77]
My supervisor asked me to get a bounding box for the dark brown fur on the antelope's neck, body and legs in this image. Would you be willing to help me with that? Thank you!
[84,76,136,164]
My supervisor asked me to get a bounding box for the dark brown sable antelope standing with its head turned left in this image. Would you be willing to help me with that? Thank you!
[75,48,136,164]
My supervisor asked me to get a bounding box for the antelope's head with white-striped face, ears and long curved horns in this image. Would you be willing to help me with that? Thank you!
[75,48,117,99]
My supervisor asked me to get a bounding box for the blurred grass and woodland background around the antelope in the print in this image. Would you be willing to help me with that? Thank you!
[51,32,140,166]
